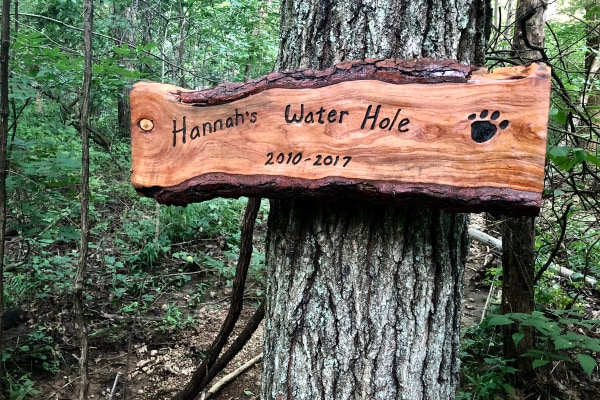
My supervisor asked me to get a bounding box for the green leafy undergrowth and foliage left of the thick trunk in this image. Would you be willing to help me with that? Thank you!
[3,0,279,392]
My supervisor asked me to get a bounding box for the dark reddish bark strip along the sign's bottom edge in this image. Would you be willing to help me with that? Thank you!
[136,173,542,216]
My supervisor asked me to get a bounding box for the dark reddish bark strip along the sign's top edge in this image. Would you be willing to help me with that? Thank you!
[174,58,477,107]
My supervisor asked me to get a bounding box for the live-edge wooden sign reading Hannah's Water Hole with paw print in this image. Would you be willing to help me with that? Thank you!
[131,59,550,215]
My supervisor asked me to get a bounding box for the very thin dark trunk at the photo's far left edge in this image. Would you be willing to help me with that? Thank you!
[0,0,10,390]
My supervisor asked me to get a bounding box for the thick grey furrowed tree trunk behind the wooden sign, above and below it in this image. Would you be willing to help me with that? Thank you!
[261,0,491,400]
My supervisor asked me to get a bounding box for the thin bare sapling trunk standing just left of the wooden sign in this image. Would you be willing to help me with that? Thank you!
[73,0,94,400]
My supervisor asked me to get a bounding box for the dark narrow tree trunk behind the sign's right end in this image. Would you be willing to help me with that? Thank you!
[500,0,547,382]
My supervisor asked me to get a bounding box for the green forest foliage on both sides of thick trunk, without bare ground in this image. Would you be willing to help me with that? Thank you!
[0,0,600,399]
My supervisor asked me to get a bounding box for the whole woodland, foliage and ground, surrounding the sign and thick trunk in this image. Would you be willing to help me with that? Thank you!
[0,0,600,399]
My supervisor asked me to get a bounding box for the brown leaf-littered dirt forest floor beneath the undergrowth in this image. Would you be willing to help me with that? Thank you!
[5,216,600,400]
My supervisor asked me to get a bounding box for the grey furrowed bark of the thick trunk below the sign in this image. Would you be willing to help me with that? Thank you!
[262,201,468,399]
